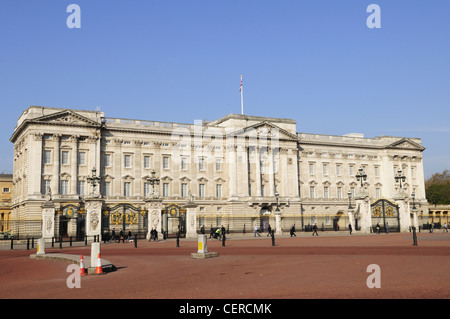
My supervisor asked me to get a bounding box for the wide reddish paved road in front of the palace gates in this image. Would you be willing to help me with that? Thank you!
[0,233,450,299]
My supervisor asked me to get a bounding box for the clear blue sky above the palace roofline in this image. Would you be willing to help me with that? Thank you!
[0,0,450,177]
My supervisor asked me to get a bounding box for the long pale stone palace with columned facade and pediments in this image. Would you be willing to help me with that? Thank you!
[10,106,428,238]
